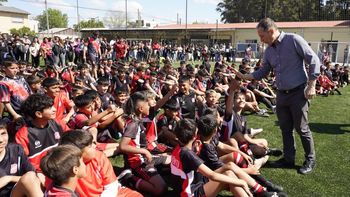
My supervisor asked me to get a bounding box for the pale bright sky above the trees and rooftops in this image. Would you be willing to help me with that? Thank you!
[3,0,220,27]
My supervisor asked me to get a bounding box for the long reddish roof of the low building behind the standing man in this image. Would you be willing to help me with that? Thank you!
[154,20,350,30]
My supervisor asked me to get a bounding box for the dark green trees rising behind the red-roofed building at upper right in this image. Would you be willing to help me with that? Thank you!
[216,0,350,23]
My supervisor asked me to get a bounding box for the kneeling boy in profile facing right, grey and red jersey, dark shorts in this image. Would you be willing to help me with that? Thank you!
[120,91,170,196]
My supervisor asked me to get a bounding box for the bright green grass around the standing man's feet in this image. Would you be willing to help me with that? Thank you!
[112,60,350,197]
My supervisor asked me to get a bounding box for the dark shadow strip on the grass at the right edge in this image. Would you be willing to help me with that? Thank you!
[309,123,350,134]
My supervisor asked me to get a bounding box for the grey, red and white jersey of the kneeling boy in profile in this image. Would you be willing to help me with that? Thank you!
[123,120,147,168]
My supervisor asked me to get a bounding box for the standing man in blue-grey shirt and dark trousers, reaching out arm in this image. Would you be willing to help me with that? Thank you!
[236,18,320,174]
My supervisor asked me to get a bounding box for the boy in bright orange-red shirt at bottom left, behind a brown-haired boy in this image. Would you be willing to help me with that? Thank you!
[60,130,142,197]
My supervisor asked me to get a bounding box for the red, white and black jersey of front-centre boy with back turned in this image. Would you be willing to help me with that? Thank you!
[170,145,205,197]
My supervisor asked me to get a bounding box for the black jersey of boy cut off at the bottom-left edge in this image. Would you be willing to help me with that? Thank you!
[0,143,34,196]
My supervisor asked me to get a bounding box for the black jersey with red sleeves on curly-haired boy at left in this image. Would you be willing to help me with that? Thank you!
[16,120,67,171]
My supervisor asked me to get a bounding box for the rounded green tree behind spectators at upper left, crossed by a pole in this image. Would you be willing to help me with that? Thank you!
[36,8,68,31]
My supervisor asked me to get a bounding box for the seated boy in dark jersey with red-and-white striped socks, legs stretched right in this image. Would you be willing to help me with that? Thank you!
[198,115,283,196]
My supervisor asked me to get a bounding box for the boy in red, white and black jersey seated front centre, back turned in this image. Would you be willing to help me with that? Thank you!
[171,119,252,197]
